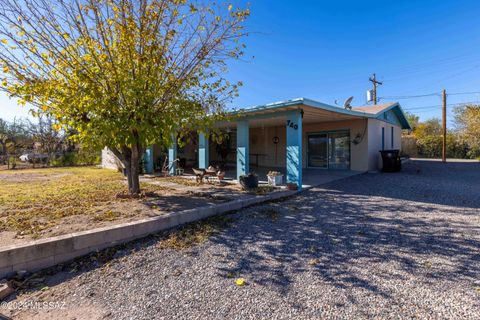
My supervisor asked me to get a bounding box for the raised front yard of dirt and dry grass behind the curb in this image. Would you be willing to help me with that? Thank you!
[0,167,266,247]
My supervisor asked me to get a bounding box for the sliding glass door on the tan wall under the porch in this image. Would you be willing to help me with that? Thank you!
[307,131,350,169]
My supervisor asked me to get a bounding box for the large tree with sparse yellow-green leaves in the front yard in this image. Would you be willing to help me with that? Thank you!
[0,0,249,195]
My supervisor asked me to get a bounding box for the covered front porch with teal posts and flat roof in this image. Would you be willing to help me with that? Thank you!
[147,99,368,189]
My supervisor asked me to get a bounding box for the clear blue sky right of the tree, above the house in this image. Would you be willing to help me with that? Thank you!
[0,0,480,125]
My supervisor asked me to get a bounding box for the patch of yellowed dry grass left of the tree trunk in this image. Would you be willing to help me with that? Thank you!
[0,167,167,236]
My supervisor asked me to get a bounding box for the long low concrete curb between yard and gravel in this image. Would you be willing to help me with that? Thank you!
[0,191,300,279]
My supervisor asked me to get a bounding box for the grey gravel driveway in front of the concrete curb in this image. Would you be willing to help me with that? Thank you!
[4,161,480,319]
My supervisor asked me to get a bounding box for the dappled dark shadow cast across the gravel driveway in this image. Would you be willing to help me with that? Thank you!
[212,161,480,297]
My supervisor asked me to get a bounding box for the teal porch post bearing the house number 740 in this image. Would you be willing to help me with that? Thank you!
[286,110,302,190]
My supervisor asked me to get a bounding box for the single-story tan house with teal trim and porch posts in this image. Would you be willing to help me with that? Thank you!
[102,98,410,187]
